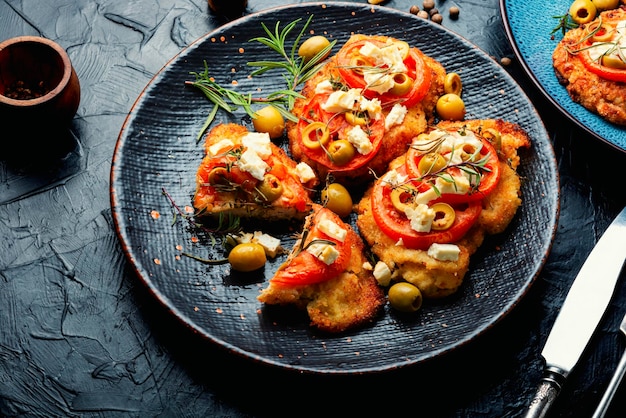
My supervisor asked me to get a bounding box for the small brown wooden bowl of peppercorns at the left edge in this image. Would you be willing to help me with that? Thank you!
[0,36,80,131]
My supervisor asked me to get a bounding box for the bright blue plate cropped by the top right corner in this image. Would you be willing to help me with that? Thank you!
[500,0,626,152]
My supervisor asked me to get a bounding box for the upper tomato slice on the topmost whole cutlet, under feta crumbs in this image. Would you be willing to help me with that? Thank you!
[337,39,432,107]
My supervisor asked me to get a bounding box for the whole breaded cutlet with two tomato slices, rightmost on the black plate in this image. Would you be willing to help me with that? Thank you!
[357,120,530,298]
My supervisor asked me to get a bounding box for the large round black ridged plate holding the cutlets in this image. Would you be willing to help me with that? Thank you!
[111,3,558,373]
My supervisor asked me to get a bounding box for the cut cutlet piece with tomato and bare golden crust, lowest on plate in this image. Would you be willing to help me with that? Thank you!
[258,205,385,333]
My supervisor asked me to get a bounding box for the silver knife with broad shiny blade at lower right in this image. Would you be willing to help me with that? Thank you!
[526,208,626,418]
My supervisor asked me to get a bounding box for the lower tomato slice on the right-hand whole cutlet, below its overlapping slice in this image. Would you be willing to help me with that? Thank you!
[371,171,482,250]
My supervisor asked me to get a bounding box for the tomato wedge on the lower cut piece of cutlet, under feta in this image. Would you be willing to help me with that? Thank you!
[272,208,354,286]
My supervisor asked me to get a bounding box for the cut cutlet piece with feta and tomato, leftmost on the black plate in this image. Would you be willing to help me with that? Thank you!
[193,123,318,221]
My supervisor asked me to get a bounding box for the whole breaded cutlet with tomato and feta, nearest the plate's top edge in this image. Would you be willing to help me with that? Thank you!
[287,35,446,185]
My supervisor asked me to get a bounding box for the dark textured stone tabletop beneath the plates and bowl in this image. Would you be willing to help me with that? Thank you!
[0,0,626,417]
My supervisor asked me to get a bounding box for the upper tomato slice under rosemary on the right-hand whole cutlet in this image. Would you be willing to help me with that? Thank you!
[405,130,500,203]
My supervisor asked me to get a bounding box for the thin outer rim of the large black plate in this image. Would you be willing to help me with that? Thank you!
[110,1,560,374]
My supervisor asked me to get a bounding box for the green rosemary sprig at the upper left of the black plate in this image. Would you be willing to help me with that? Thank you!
[185,15,337,141]
